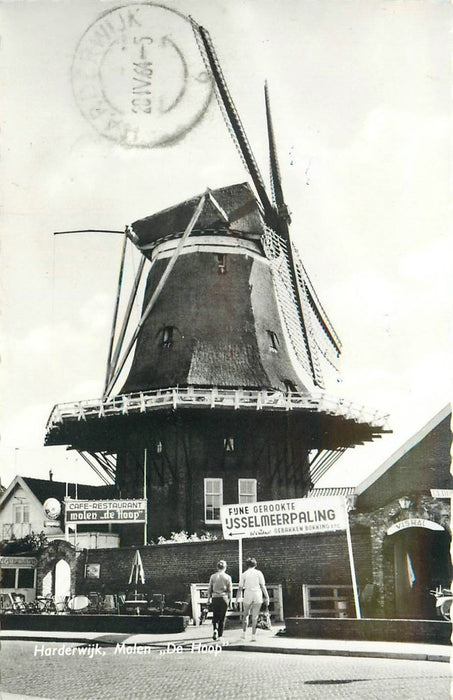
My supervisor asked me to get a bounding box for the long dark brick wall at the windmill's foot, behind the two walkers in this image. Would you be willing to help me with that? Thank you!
[76,528,370,614]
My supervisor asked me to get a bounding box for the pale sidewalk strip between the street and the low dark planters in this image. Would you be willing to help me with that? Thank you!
[0,623,452,663]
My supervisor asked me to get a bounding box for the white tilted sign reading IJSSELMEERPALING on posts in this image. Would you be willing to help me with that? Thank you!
[220,496,348,539]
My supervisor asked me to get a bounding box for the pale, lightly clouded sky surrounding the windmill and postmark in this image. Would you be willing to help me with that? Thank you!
[0,0,452,485]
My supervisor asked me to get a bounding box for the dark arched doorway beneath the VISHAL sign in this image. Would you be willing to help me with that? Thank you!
[386,527,451,620]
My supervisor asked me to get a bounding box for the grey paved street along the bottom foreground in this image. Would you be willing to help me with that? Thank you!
[1,640,450,700]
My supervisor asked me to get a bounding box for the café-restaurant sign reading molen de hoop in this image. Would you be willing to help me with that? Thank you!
[64,498,146,523]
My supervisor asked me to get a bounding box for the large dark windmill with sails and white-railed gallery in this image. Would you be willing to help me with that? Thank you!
[46,17,384,544]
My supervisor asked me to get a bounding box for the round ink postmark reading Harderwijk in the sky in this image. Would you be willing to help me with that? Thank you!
[72,3,213,148]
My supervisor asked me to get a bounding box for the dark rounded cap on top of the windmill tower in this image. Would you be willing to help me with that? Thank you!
[130,182,264,248]
